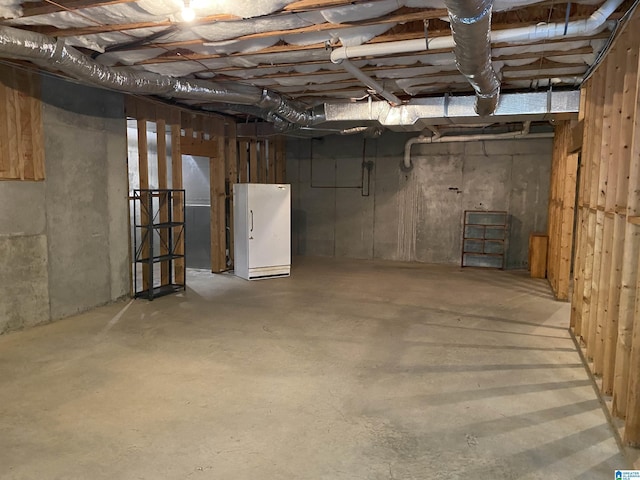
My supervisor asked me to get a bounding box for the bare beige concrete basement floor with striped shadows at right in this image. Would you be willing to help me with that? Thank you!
[0,258,626,480]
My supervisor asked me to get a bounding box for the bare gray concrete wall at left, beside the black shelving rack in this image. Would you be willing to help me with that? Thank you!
[0,73,129,333]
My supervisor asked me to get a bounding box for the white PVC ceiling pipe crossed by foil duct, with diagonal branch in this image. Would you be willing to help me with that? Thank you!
[331,0,624,103]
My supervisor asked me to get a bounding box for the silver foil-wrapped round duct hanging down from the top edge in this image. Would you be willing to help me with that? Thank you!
[445,0,500,116]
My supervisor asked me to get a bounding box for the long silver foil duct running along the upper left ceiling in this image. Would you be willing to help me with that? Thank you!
[0,26,322,125]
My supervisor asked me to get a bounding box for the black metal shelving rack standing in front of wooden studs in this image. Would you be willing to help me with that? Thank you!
[131,189,186,300]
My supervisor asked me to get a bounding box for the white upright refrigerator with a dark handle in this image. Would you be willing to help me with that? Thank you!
[233,183,291,280]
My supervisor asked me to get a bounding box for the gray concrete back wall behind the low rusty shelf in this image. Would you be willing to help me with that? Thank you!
[287,132,552,268]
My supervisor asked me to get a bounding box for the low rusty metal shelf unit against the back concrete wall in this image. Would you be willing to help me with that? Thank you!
[462,210,508,269]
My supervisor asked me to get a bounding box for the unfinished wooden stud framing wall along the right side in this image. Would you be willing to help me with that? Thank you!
[564,7,640,446]
